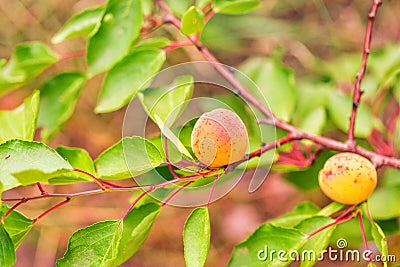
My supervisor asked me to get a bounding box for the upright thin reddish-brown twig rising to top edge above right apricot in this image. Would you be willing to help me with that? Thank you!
[347,0,382,146]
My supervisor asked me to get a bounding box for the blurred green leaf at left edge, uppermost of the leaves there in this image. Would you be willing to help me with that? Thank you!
[0,42,58,95]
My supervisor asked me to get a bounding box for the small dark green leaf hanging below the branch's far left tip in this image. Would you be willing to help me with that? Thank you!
[0,205,33,249]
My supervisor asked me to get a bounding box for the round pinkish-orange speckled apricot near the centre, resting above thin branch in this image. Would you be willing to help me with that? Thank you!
[191,108,249,168]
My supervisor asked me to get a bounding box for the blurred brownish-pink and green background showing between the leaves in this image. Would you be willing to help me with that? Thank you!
[0,0,400,267]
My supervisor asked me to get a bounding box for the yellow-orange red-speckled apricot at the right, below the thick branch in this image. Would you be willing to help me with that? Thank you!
[318,152,377,205]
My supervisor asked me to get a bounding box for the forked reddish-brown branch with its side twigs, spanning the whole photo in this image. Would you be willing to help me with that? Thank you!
[1,0,400,226]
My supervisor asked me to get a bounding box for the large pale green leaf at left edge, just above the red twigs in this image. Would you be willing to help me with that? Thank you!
[0,140,71,191]
